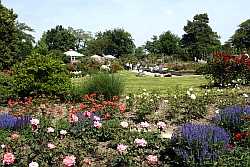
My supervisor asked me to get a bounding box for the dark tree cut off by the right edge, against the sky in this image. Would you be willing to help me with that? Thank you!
[229,19,250,51]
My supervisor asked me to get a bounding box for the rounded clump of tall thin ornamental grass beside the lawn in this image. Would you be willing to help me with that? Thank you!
[84,73,124,100]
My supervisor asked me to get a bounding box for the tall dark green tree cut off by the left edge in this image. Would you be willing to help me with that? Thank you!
[0,4,20,69]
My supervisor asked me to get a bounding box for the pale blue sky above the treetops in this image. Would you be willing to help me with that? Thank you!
[1,0,250,47]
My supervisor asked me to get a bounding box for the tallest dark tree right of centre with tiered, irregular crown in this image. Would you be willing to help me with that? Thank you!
[181,13,220,60]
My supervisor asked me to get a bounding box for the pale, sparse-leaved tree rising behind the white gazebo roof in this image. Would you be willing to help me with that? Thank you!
[68,27,94,51]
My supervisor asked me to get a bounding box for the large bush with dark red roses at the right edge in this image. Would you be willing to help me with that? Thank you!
[200,52,250,86]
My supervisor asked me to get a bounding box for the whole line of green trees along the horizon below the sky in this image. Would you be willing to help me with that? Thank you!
[0,4,250,70]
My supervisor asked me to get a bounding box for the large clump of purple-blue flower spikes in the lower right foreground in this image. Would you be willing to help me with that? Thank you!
[171,123,229,166]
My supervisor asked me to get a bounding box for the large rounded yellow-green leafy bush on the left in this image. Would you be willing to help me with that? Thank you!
[13,54,71,97]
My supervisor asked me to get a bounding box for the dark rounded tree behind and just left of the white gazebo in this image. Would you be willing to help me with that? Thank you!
[41,25,76,52]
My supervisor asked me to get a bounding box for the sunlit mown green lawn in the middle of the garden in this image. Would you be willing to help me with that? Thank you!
[74,70,208,95]
